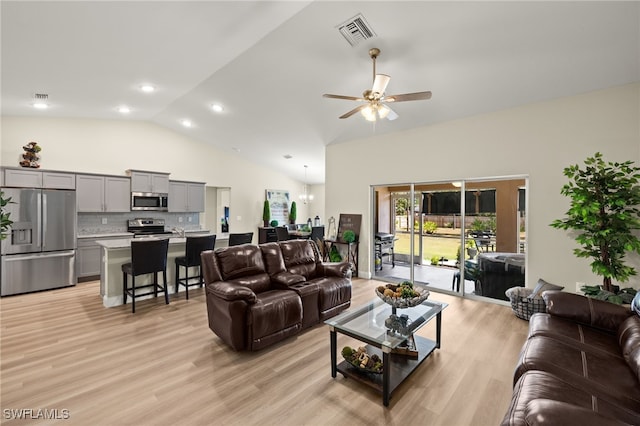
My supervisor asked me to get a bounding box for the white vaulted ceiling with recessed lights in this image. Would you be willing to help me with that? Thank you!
[1,0,640,183]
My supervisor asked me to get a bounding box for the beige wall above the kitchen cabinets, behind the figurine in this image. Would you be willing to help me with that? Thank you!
[0,117,316,241]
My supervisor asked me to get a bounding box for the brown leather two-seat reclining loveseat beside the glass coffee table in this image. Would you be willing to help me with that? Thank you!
[202,240,351,351]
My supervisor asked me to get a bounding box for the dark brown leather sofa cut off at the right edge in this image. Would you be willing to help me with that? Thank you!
[502,291,640,426]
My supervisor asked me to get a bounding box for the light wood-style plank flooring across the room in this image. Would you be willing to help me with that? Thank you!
[0,279,528,426]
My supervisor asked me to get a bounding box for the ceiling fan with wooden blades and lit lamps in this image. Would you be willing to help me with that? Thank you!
[322,47,431,121]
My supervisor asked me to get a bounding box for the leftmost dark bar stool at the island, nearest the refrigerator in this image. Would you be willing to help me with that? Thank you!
[122,238,169,313]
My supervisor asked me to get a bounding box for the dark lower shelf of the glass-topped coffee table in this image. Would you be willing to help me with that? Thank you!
[336,336,438,405]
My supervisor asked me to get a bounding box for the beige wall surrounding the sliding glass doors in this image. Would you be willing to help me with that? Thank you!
[325,83,640,291]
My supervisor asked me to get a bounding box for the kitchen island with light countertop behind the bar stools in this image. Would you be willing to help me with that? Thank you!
[98,233,229,308]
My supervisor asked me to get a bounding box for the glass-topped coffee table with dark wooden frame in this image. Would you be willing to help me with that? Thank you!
[325,299,448,406]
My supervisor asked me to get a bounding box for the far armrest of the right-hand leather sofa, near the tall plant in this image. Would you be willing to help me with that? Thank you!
[542,291,632,333]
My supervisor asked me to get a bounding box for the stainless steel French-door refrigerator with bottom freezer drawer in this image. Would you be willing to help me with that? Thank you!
[0,188,76,296]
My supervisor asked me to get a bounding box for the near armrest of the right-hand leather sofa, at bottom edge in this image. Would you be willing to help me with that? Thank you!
[524,400,628,426]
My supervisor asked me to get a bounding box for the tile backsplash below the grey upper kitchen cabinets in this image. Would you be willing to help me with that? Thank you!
[78,212,202,235]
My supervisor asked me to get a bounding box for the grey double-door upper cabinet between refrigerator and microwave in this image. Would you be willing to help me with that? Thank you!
[76,175,131,212]
